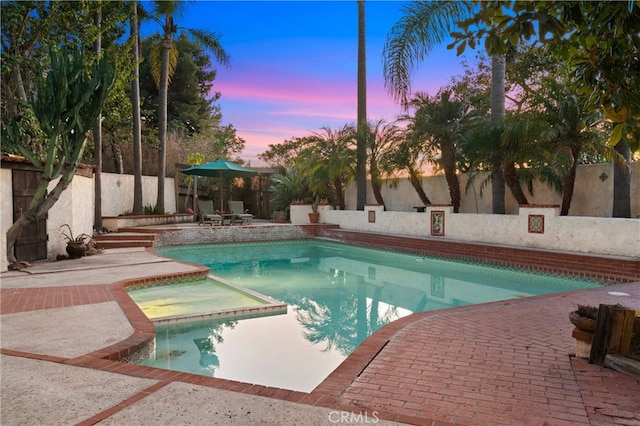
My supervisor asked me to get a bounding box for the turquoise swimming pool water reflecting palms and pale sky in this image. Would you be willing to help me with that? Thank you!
[142,240,597,392]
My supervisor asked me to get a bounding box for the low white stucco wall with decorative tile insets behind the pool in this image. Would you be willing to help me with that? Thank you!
[291,206,640,257]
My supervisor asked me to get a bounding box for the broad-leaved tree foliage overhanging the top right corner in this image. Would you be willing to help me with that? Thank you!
[451,0,640,150]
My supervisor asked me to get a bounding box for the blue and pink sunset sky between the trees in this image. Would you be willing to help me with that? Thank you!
[149,0,474,166]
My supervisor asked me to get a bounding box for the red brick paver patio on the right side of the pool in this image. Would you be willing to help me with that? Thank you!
[320,284,640,425]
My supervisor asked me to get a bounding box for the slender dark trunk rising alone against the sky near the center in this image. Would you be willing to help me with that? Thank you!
[356,0,369,210]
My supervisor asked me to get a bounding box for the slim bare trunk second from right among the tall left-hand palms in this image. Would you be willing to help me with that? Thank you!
[131,0,143,214]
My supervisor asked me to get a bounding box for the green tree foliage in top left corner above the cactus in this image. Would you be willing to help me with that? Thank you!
[0,1,128,158]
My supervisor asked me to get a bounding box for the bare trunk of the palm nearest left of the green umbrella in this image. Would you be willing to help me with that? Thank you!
[156,15,173,212]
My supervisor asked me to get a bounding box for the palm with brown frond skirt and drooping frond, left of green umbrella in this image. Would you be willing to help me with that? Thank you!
[151,0,230,211]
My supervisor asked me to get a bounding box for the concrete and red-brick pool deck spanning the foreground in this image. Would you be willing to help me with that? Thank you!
[0,245,640,425]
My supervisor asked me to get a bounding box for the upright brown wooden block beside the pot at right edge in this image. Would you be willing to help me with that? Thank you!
[589,305,635,365]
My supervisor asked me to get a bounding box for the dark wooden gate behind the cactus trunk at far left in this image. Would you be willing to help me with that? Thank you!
[12,169,47,262]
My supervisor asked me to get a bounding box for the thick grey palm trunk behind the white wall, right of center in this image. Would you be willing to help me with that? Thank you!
[491,56,506,214]
